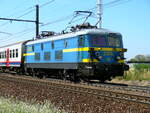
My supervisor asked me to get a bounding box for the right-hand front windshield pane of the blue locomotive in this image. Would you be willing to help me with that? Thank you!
[108,33,121,47]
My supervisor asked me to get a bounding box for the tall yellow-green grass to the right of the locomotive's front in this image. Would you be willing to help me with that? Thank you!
[120,64,150,81]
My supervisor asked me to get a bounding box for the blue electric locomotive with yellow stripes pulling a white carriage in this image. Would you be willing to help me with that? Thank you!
[22,26,128,82]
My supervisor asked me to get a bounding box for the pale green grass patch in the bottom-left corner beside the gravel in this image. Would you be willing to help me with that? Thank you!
[0,97,64,113]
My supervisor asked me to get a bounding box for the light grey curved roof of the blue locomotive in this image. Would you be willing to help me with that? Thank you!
[26,29,120,45]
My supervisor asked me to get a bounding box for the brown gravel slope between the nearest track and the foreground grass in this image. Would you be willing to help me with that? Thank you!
[0,73,150,113]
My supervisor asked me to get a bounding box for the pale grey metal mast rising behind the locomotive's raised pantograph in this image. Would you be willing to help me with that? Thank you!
[97,0,103,28]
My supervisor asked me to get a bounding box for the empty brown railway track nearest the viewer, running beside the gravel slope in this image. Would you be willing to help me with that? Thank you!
[0,76,150,105]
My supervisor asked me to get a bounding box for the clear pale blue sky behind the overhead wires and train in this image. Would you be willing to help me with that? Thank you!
[0,0,150,60]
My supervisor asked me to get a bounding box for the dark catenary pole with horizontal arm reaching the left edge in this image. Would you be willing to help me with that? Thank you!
[0,5,41,38]
